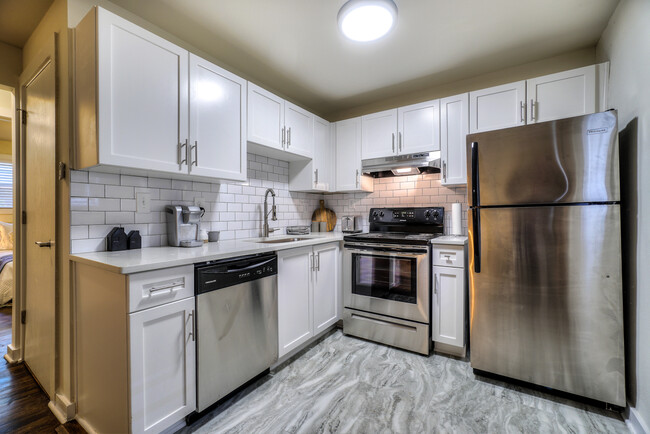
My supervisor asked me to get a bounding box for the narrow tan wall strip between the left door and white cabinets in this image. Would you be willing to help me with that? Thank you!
[23,0,75,418]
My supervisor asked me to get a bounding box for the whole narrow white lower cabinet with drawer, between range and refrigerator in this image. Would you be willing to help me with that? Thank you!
[431,244,467,356]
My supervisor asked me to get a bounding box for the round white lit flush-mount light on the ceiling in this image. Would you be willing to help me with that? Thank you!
[338,0,397,42]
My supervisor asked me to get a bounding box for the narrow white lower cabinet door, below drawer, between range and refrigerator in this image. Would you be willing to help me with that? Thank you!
[432,267,465,347]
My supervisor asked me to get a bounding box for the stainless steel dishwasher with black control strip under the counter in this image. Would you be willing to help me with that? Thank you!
[195,253,278,412]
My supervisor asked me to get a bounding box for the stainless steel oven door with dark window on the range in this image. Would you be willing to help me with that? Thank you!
[343,243,430,324]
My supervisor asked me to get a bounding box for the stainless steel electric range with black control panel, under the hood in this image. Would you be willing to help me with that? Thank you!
[343,208,444,354]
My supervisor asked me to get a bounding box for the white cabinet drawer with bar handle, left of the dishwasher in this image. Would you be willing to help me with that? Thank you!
[129,265,194,312]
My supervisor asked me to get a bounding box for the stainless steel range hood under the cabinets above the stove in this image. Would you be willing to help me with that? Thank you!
[361,151,440,178]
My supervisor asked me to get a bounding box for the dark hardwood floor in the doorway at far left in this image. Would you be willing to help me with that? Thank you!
[0,307,85,434]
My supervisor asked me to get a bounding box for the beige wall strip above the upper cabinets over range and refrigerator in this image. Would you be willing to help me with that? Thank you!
[325,47,596,122]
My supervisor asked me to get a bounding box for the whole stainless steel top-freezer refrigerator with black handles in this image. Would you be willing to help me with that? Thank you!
[467,111,625,406]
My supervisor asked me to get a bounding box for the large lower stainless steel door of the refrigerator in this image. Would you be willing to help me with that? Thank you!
[469,205,625,406]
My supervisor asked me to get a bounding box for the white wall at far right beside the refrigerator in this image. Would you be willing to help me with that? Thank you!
[597,0,650,432]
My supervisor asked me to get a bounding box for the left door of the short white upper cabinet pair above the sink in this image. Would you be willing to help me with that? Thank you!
[247,82,284,149]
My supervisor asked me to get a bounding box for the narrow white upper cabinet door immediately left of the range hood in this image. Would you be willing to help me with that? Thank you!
[336,117,361,191]
